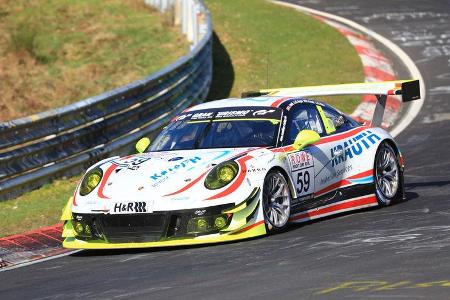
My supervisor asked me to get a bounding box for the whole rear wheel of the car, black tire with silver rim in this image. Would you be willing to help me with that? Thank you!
[374,142,402,206]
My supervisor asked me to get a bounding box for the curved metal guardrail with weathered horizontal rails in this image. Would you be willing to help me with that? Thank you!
[0,0,212,200]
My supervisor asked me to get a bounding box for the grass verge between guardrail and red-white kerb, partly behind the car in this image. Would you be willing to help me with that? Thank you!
[0,0,364,236]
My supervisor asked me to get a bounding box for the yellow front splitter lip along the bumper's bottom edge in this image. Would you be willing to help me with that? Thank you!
[63,223,266,249]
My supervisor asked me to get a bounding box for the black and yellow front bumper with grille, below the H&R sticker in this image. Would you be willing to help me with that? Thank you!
[61,188,266,249]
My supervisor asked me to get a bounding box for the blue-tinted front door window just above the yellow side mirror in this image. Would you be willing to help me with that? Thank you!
[284,104,324,145]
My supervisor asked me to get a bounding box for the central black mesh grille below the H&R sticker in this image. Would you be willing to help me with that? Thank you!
[96,214,167,243]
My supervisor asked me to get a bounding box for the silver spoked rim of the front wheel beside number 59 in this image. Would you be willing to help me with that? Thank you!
[263,173,291,228]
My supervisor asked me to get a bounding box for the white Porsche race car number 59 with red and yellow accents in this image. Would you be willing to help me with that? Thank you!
[61,80,420,249]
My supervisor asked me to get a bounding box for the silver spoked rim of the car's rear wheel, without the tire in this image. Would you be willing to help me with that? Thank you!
[376,147,399,199]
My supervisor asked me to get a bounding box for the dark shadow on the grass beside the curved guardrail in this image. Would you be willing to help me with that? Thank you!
[207,32,234,101]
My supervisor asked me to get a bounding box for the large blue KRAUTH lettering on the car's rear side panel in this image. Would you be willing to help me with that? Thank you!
[331,130,381,167]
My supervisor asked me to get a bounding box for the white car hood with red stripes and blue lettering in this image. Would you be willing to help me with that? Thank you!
[77,148,266,210]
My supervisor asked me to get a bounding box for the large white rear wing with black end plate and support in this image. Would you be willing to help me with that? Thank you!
[242,80,420,126]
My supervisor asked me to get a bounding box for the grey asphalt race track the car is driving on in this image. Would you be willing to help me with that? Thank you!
[0,0,450,299]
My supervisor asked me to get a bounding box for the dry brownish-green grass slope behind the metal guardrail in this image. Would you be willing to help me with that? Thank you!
[0,0,188,120]
